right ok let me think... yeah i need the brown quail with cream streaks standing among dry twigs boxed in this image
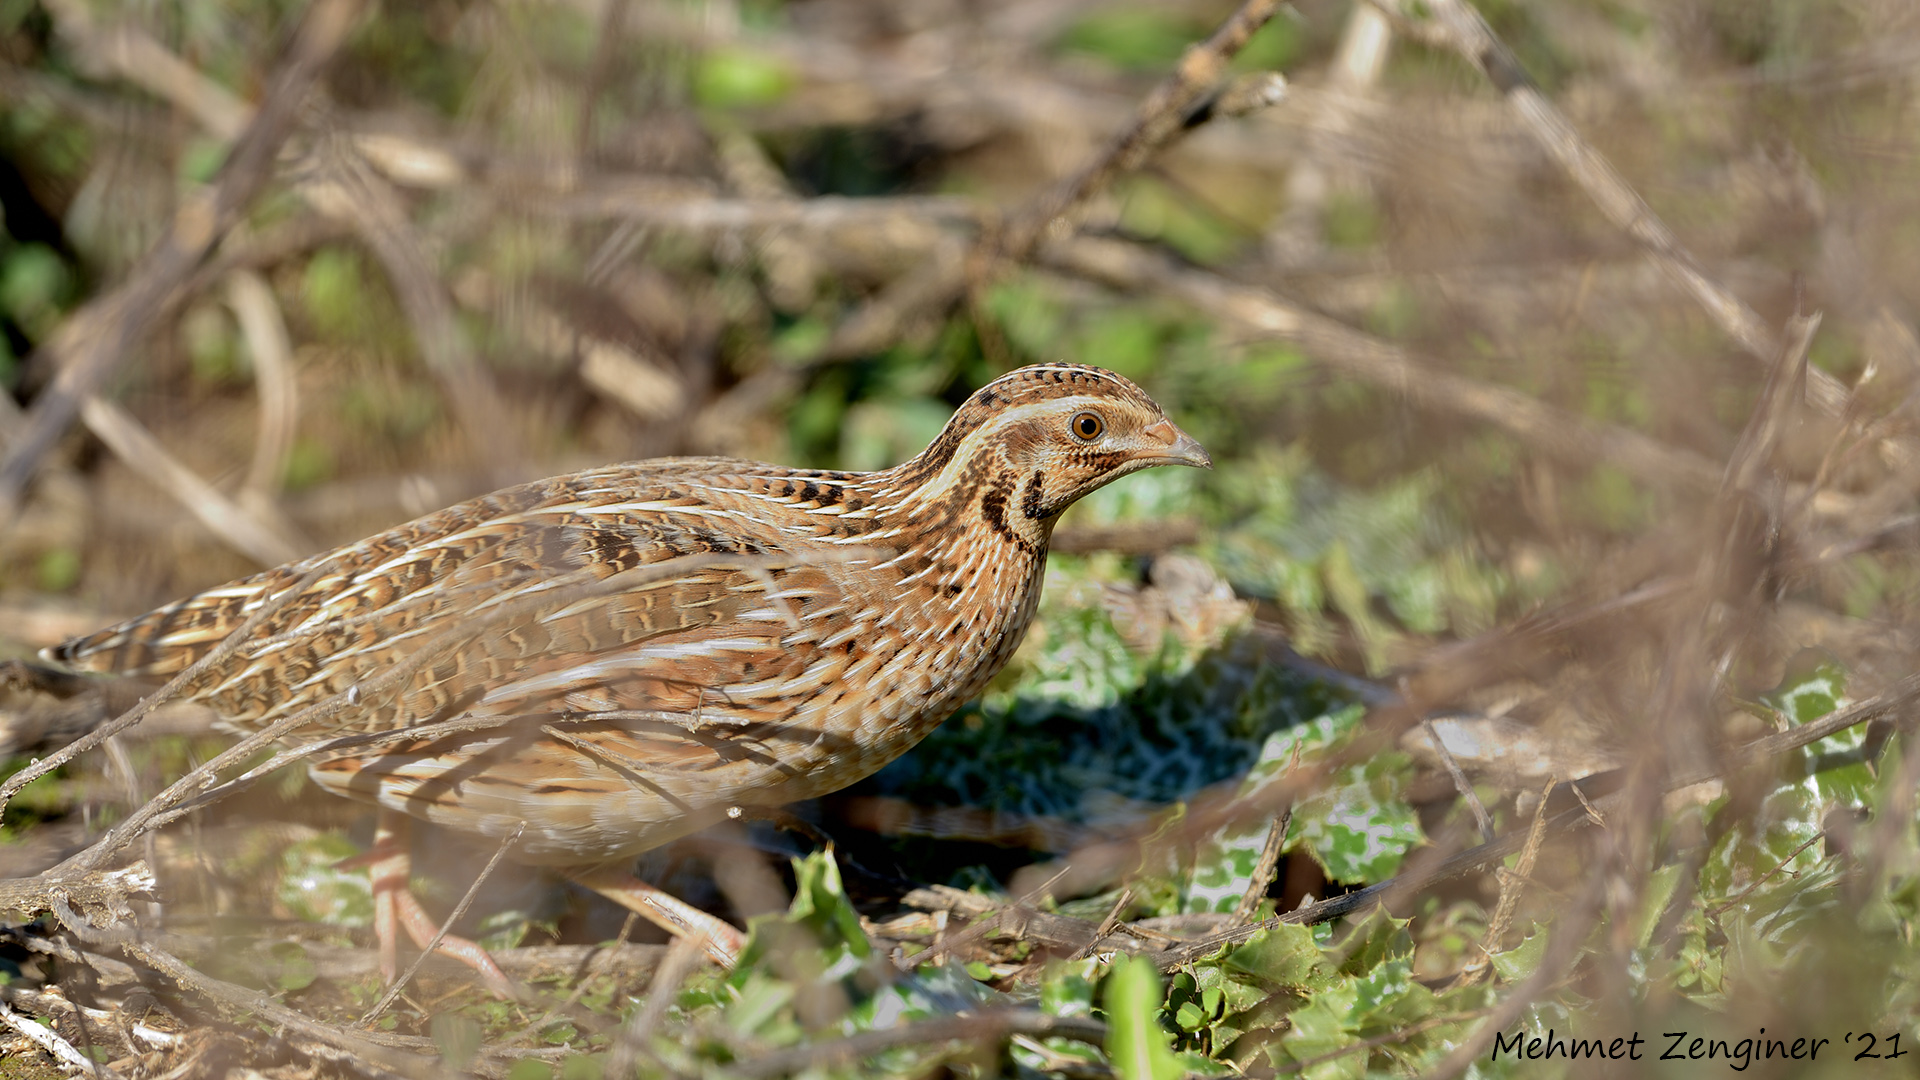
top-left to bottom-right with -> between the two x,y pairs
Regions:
46,365 -> 1210,983
